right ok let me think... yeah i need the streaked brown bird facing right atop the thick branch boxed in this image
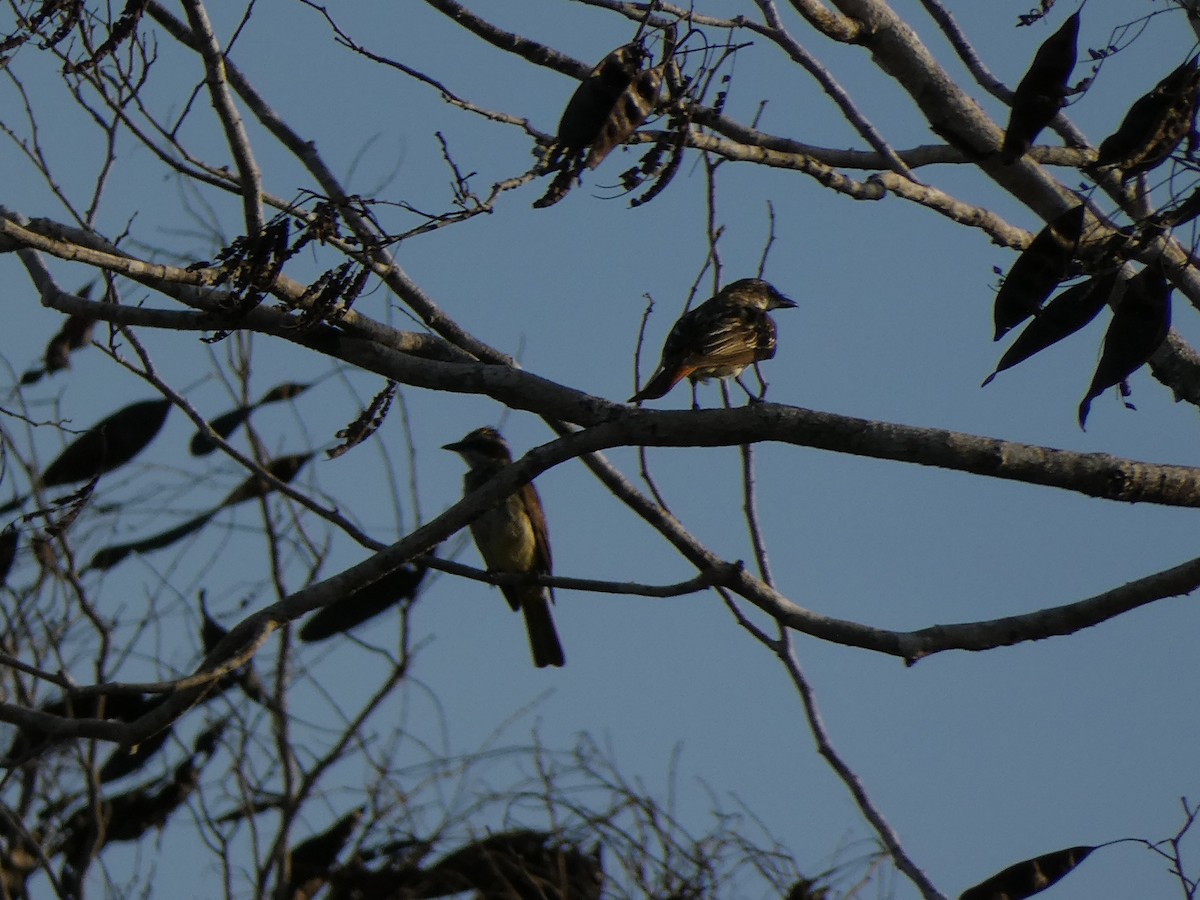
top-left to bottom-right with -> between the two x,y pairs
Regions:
629,278 -> 796,408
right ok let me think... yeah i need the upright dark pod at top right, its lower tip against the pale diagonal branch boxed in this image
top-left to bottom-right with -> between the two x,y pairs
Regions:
1000,11 -> 1079,164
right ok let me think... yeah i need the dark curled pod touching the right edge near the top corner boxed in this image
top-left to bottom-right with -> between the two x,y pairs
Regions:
1096,56 -> 1200,179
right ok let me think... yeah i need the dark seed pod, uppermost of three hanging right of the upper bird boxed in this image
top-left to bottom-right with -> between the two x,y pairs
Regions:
992,203 -> 1086,341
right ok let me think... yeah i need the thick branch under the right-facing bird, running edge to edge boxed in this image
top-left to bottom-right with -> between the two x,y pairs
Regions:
0,207 -> 1200,506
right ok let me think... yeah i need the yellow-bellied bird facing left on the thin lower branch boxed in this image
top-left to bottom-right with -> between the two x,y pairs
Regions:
443,426 -> 565,668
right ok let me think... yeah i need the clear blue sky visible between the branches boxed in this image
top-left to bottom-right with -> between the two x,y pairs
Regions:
0,0 -> 1200,900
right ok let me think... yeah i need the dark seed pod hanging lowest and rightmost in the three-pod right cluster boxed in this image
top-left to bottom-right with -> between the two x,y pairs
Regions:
1079,264 -> 1171,430
